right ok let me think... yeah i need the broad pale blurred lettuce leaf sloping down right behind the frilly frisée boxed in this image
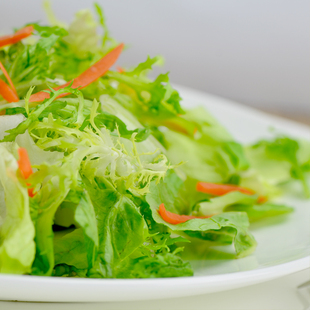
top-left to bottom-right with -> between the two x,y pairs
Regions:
163,108 -> 249,183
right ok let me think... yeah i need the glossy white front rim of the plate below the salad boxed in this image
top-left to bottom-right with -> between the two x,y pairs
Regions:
0,256 -> 310,302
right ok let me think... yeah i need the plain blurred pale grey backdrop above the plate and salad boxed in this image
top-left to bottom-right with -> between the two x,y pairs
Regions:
0,0 -> 310,125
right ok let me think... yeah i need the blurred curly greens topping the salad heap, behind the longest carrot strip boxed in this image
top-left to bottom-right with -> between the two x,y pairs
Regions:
0,5 -> 117,100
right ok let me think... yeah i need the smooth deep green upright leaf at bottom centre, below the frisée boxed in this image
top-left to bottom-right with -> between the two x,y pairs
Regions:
83,178 -> 148,278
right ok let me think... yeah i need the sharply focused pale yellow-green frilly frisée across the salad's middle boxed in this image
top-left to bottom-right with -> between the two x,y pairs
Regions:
3,87 -> 170,199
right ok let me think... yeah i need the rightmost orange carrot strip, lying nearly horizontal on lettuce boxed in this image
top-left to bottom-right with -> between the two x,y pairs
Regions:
196,182 -> 267,203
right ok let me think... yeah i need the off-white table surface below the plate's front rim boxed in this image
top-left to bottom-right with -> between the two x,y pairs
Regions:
0,269 -> 310,310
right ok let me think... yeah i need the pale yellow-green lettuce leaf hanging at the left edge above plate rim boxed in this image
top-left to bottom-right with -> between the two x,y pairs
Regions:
0,144 -> 35,274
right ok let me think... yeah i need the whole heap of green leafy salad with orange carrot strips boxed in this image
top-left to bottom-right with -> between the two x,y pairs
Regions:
0,5 -> 310,278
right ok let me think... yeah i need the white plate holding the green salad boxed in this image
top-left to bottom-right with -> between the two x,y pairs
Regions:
0,87 -> 310,302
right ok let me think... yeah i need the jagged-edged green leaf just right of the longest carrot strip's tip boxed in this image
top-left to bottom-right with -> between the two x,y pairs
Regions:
106,58 -> 184,120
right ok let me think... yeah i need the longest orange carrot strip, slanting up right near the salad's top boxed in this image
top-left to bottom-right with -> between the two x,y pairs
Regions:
29,43 -> 124,102
